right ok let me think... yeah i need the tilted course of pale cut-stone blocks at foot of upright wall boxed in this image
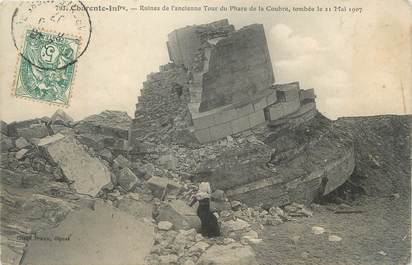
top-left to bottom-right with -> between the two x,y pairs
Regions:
191,82 -> 316,143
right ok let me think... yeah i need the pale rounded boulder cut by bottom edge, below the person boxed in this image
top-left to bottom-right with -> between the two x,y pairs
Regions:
197,243 -> 258,265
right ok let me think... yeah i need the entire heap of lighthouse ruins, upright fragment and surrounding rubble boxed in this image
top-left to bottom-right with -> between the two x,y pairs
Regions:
0,20 -> 410,265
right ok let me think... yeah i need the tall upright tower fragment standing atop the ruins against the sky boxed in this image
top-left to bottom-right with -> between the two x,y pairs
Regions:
130,20 -> 316,144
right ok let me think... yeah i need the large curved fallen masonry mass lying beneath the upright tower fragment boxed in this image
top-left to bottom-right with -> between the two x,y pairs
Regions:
195,114 -> 355,205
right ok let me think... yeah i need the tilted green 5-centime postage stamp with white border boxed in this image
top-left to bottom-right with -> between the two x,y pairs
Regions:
14,29 -> 80,105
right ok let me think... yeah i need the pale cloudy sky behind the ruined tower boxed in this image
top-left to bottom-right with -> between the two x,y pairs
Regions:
0,0 -> 412,122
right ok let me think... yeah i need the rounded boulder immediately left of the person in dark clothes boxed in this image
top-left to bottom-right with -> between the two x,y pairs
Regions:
156,200 -> 200,230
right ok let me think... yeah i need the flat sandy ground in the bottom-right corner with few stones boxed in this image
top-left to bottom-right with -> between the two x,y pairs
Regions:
255,193 -> 411,265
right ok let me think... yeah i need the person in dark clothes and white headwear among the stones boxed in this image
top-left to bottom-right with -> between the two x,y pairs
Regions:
190,182 -> 220,237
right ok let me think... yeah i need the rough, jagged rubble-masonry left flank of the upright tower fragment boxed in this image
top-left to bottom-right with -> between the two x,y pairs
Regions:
129,64 -> 194,144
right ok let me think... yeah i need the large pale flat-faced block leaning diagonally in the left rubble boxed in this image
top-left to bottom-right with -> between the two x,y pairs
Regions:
40,135 -> 110,196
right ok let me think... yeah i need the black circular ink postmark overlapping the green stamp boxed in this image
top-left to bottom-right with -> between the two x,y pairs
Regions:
11,1 -> 92,70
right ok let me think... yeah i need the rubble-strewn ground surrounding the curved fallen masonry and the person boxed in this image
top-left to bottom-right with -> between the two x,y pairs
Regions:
1,111 -> 411,265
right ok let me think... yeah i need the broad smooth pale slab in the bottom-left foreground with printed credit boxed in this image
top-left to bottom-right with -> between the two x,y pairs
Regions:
21,200 -> 154,265
